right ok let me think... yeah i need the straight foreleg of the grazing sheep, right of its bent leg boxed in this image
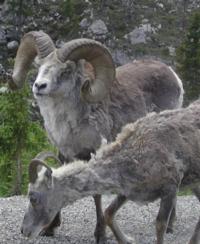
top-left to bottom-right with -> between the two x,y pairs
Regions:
156,186 -> 177,244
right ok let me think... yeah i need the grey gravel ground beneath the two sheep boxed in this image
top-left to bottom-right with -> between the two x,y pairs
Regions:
0,196 -> 200,244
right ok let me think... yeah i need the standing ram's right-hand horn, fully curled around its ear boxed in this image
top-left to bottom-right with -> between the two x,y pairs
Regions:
57,38 -> 115,102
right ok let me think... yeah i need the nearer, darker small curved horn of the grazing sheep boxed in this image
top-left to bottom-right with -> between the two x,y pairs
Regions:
28,158 -> 52,184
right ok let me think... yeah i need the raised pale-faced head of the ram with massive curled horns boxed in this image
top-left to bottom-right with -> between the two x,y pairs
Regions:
9,31 -> 115,102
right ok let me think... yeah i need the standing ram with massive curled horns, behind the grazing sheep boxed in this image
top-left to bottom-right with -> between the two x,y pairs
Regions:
9,31 -> 183,242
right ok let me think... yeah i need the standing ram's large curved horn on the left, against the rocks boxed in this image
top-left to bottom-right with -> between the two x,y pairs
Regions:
9,31 -> 55,89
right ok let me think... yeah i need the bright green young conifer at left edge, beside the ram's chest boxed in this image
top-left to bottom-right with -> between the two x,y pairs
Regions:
0,84 -> 52,196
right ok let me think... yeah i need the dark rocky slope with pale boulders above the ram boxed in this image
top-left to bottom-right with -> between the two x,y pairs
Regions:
0,0 -> 200,65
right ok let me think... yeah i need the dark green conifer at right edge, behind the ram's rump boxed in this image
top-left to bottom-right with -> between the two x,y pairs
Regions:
177,11 -> 200,102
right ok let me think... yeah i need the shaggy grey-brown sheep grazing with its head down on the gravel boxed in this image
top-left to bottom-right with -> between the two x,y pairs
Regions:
22,100 -> 200,244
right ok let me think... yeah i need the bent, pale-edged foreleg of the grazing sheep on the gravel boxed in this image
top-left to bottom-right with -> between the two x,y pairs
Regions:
104,195 -> 134,244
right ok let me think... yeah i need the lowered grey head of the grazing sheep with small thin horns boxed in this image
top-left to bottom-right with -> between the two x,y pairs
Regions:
21,153 -> 62,238
